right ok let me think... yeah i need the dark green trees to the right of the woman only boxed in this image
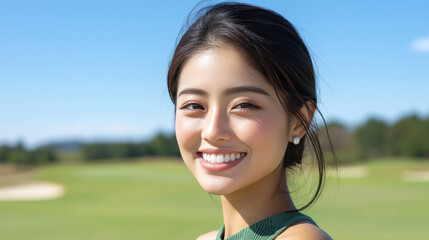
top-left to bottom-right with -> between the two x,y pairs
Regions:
321,115 -> 429,162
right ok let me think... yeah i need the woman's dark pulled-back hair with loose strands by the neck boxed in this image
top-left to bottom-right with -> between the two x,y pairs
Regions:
167,2 -> 332,210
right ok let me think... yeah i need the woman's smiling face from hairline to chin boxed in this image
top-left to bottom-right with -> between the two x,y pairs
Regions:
175,47 -> 292,195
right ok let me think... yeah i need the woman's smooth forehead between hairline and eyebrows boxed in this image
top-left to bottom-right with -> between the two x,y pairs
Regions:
178,47 -> 274,91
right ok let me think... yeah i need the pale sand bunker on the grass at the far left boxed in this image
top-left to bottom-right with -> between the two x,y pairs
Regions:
0,182 -> 64,201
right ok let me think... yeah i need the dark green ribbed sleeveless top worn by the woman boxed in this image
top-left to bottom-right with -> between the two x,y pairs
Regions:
216,211 -> 317,240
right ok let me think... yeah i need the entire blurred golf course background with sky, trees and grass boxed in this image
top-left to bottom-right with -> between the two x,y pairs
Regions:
0,0 -> 429,240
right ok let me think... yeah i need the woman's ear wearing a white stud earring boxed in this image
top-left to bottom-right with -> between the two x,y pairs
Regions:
289,101 -> 316,142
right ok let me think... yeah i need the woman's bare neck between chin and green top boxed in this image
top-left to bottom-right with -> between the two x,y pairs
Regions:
221,167 -> 296,238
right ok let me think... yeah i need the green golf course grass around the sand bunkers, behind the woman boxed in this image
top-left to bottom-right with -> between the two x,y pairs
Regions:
0,159 -> 429,240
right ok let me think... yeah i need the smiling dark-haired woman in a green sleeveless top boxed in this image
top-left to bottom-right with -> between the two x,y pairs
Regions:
167,3 -> 330,240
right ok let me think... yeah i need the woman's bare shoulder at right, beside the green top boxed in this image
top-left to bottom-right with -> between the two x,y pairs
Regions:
276,223 -> 332,240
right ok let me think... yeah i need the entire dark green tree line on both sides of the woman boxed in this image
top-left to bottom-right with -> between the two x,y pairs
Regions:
0,115 -> 429,165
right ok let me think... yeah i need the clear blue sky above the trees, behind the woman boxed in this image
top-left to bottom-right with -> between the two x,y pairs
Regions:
0,0 -> 429,146
